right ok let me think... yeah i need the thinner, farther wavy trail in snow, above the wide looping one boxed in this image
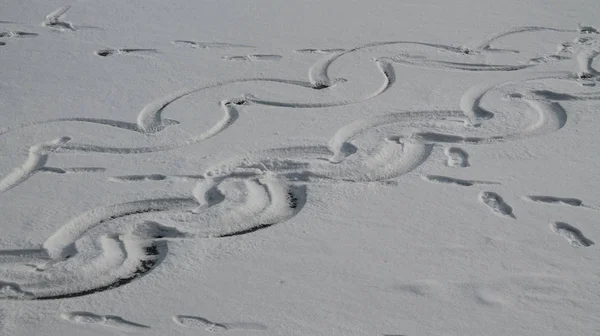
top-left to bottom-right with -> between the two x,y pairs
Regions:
0,25 -> 571,154
